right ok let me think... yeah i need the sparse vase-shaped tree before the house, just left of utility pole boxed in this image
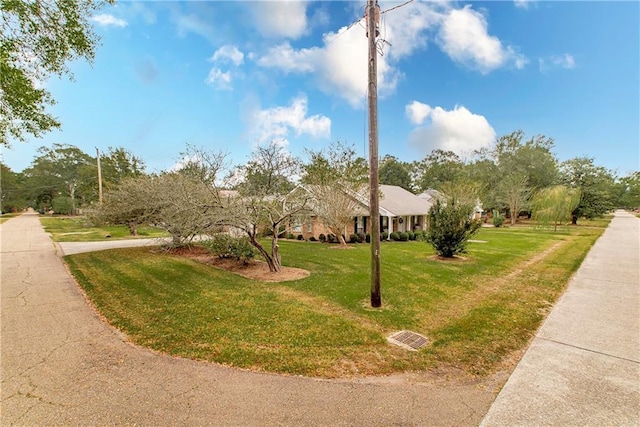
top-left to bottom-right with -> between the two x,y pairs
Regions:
302,143 -> 368,246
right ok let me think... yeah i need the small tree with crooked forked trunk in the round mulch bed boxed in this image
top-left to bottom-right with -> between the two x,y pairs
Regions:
221,142 -> 311,272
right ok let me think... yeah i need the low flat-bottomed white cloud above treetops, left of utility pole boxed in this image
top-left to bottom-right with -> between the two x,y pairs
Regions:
252,95 -> 331,144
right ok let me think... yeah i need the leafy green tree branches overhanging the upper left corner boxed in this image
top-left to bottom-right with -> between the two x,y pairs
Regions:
0,0 -> 112,146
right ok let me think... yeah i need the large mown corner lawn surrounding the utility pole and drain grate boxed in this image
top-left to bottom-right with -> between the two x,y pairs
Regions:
65,227 -> 604,377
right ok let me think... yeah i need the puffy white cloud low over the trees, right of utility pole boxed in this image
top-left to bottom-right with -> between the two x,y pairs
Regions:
405,101 -> 496,154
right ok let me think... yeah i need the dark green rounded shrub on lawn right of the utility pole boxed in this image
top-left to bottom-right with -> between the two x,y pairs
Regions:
424,199 -> 481,258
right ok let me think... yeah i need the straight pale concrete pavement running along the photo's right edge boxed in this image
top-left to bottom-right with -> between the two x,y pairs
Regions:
481,211 -> 640,426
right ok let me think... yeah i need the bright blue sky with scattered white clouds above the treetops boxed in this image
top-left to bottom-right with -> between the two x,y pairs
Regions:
2,0 -> 640,175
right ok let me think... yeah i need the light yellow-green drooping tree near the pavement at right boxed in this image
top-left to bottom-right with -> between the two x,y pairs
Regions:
531,185 -> 580,231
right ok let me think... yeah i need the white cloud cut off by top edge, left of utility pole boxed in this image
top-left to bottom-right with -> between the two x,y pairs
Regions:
252,0 -> 307,39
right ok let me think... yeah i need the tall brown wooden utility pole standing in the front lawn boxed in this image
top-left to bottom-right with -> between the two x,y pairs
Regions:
366,0 -> 382,307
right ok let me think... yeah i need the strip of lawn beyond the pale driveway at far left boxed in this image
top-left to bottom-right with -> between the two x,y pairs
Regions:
40,216 -> 168,242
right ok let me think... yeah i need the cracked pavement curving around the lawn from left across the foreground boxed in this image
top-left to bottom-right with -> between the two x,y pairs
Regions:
0,214 -> 505,426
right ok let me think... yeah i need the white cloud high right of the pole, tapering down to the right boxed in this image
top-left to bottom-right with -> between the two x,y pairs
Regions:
437,5 -> 528,74
